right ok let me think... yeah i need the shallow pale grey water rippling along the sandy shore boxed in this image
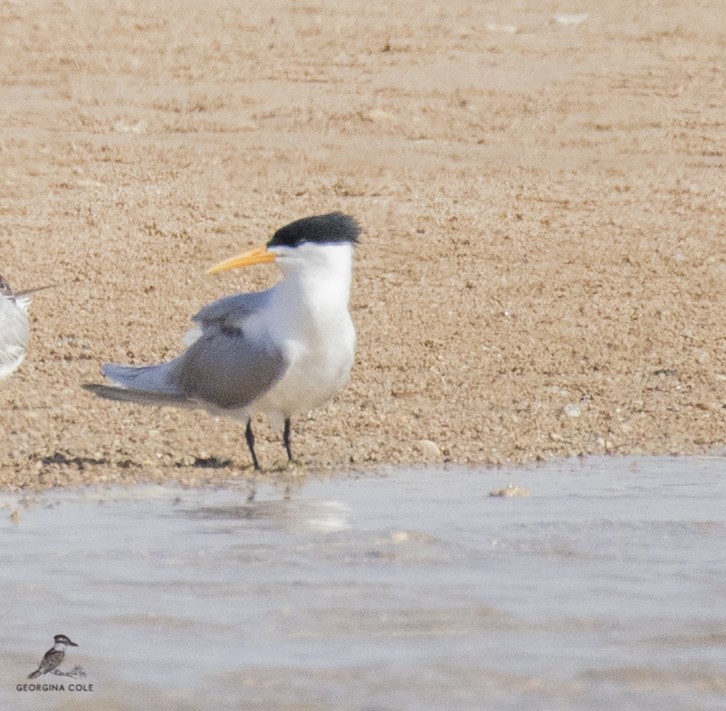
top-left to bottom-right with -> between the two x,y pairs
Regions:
0,457 -> 726,711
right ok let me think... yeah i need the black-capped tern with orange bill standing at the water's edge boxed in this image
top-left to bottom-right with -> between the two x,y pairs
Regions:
85,212 -> 360,470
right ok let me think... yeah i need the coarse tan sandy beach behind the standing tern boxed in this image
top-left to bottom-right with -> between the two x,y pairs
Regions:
0,0 -> 726,490
